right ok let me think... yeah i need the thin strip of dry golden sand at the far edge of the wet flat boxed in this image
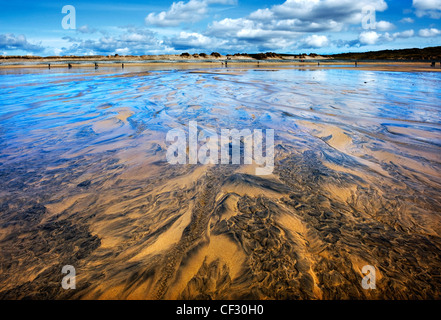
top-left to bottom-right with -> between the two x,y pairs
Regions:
0,56 -> 441,73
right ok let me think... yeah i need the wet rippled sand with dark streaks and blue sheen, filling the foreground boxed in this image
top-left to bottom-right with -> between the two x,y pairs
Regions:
0,67 -> 441,299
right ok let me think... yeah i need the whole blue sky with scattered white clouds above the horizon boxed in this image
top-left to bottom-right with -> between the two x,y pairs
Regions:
0,0 -> 441,56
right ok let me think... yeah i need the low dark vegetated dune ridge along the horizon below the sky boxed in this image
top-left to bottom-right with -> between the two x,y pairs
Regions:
0,46 -> 441,61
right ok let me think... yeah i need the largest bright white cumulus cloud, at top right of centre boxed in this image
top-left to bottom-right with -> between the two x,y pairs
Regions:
207,0 -> 386,50
